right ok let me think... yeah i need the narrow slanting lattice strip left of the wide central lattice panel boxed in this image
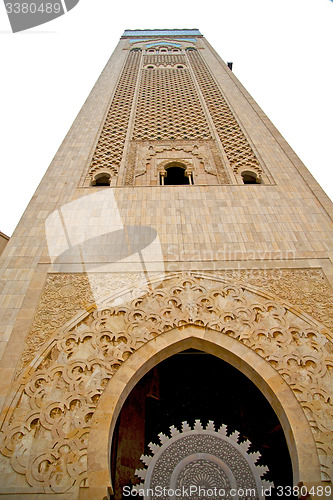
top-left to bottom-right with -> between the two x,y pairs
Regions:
90,51 -> 141,172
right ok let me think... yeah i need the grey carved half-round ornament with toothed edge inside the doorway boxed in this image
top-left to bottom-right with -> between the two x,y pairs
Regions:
134,420 -> 274,500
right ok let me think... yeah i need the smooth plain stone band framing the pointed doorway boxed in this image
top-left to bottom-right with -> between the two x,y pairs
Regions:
87,325 -> 320,498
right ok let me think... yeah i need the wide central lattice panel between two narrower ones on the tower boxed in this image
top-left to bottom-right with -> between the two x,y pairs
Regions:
133,66 -> 211,140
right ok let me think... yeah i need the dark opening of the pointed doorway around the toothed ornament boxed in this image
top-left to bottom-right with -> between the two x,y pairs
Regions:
111,349 -> 293,500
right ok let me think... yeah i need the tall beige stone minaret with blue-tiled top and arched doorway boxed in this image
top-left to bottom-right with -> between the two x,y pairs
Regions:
0,29 -> 333,500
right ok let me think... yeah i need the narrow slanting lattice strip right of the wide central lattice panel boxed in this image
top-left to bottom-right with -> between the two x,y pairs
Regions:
187,50 -> 262,174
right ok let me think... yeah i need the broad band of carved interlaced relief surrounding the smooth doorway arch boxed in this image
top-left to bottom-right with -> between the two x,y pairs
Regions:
1,270 -> 333,492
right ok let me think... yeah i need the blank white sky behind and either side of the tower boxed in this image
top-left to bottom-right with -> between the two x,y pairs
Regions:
0,0 -> 333,236
